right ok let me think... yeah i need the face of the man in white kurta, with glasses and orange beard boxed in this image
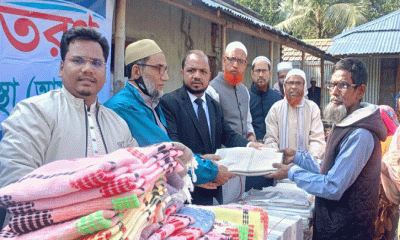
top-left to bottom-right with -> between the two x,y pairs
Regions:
284,75 -> 305,106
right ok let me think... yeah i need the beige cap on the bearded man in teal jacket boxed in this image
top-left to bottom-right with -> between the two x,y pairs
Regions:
125,39 -> 162,65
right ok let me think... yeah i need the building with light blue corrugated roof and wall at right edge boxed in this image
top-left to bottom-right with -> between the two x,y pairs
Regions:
328,10 -> 400,107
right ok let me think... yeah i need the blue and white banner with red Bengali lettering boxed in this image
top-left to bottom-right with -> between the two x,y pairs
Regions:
0,0 -> 115,126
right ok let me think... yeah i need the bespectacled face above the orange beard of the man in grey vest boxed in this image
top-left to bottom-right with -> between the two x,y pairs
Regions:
223,48 -> 247,75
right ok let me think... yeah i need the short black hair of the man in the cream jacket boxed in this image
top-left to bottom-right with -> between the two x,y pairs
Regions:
60,27 -> 110,61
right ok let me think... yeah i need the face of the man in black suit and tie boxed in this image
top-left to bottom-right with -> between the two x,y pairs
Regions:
181,54 -> 211,97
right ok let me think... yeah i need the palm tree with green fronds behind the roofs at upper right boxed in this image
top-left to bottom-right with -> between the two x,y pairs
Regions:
275,0 -> 369,38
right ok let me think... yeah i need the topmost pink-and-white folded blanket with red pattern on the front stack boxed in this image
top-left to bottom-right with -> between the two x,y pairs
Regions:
0,143 -> 182,207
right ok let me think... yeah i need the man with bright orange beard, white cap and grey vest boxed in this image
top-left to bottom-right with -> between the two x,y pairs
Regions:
207,41 -> 256,142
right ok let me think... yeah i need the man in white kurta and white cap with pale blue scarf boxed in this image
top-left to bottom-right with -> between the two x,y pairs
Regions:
264,69 -> 326,159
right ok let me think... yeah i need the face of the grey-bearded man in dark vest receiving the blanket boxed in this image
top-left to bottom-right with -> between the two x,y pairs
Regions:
329,70 -> 365,114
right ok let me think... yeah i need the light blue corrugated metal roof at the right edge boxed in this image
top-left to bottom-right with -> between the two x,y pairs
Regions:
327,10 -> 400,55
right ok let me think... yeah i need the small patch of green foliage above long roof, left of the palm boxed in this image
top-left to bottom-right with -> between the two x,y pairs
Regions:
236,0 -> 283,26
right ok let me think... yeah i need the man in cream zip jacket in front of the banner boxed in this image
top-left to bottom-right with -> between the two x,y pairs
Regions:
0,27 -> 138,187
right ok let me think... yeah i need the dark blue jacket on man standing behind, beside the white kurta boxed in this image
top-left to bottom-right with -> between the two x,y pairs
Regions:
249,82 -> 281,140
